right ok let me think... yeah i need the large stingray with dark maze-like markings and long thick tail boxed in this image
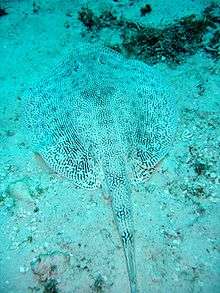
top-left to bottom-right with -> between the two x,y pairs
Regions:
25,44 -> 177,293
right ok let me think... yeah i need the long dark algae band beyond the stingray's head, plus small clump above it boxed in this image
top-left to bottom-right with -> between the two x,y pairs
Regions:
78,4 -> 220,64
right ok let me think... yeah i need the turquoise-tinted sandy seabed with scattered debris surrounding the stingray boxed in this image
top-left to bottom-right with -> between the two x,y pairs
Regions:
0,0 -> 220,293
